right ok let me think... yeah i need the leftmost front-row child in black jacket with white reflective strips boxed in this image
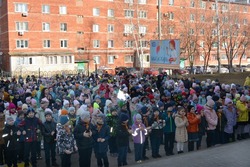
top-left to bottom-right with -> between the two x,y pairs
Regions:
3,117 -> 21,167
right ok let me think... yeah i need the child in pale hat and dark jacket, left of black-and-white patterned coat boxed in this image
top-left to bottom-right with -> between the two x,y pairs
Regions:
42,108 -> 58,167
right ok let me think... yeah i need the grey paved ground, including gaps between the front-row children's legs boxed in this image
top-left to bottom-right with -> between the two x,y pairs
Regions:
29,137 -> 250,167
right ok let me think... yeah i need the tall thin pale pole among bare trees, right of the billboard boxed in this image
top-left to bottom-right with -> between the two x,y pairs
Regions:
215,0 -> 221,73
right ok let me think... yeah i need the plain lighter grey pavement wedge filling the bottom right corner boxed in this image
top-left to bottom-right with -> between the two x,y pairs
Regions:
132,140 -> 250,167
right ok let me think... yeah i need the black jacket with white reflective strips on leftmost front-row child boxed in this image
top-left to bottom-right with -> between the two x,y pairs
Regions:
3,124 -> 20,151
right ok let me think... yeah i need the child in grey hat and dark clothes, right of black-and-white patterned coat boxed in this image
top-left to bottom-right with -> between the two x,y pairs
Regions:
74,111 -> 95,167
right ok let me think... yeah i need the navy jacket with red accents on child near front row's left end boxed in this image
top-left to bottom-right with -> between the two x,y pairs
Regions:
19,117 -> 43,142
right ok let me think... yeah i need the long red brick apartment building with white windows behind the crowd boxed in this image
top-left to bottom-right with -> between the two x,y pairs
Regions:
0,0 -> 250,75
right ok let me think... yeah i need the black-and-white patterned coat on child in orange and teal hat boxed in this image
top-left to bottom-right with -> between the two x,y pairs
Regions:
57,124 -> 76,154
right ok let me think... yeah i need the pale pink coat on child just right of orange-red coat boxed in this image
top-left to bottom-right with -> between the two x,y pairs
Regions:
204,106 -> 218,130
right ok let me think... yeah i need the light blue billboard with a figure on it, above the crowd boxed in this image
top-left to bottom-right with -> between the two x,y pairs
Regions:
150,39 -> 180,69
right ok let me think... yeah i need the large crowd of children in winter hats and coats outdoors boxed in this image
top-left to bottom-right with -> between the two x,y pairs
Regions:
0,73 -> 250,167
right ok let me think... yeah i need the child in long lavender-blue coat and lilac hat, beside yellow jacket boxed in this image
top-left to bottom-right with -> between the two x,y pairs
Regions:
223,98 -> 237,143
